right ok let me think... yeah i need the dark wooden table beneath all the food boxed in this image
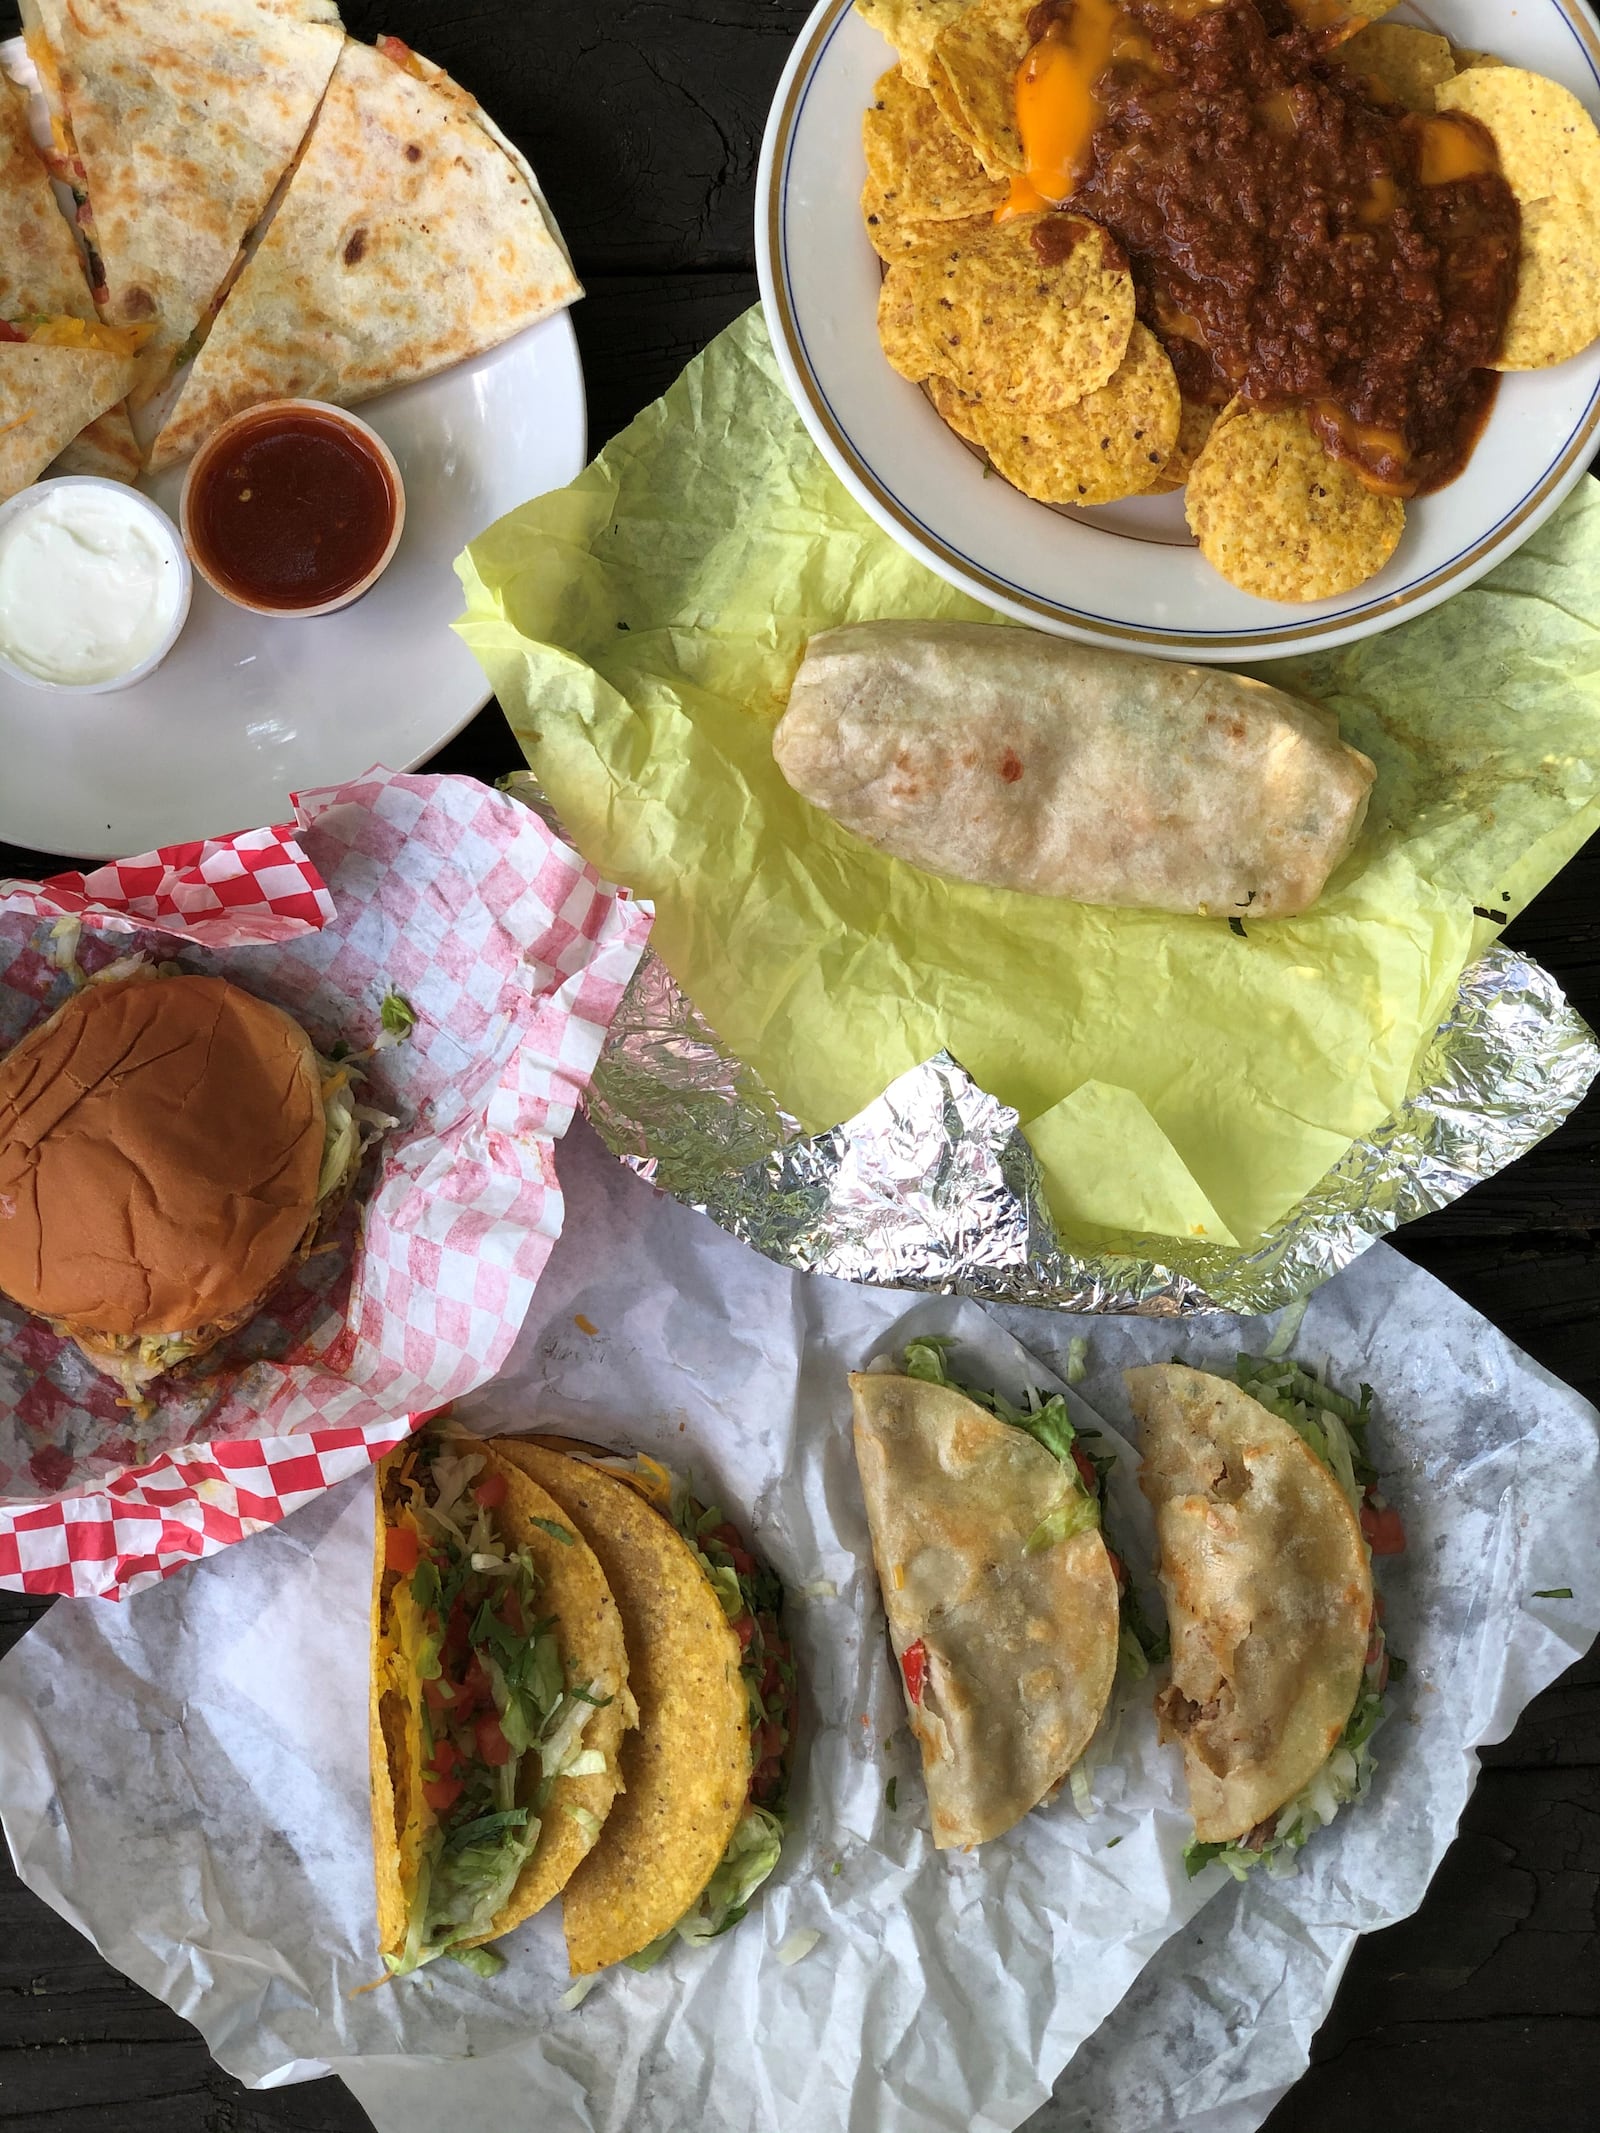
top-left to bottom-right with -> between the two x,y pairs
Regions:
0,0 -> 1600,2133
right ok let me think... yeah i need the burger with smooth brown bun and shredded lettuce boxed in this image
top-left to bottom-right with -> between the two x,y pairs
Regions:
0,962 -> 371,1399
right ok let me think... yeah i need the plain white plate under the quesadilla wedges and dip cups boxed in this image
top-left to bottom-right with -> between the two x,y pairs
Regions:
0,45 -> 587,857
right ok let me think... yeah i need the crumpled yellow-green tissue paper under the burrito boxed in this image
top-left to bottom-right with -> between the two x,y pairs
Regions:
457,311 -> 1600,1250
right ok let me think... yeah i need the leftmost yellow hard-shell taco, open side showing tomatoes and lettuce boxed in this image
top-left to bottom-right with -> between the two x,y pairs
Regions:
371,1429 -> 636,1977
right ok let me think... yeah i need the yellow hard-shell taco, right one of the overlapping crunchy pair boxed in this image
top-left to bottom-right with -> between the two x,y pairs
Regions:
495,1438 -> 794,1977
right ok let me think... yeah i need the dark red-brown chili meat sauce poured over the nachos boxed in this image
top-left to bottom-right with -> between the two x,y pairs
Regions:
1058,0 -> 1521,495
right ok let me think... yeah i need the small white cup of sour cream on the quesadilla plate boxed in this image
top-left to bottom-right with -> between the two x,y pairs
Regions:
0,474 -> 194,695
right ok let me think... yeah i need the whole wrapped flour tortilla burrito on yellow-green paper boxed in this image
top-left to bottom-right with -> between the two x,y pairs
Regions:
772,623 -> 1376,919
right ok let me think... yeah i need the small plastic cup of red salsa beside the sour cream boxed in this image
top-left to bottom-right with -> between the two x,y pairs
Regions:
179,399 -> 405,619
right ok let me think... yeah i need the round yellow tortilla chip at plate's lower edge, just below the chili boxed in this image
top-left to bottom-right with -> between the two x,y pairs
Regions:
1184,401 -> 1406,599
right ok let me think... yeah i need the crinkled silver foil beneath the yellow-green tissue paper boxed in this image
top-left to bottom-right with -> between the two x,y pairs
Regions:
506,772 -> 1600,1316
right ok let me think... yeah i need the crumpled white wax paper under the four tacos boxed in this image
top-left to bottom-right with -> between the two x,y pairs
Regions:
0,1135 -> 1600,2133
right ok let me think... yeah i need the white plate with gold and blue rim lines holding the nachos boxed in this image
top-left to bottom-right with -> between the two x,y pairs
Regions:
755,0 -> 1600,659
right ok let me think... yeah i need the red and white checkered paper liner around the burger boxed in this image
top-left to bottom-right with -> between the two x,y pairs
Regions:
0,770 -> 651,1598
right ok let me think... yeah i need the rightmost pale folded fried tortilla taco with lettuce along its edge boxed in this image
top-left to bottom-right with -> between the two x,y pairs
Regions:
1126,1357 -> 1404,1875
